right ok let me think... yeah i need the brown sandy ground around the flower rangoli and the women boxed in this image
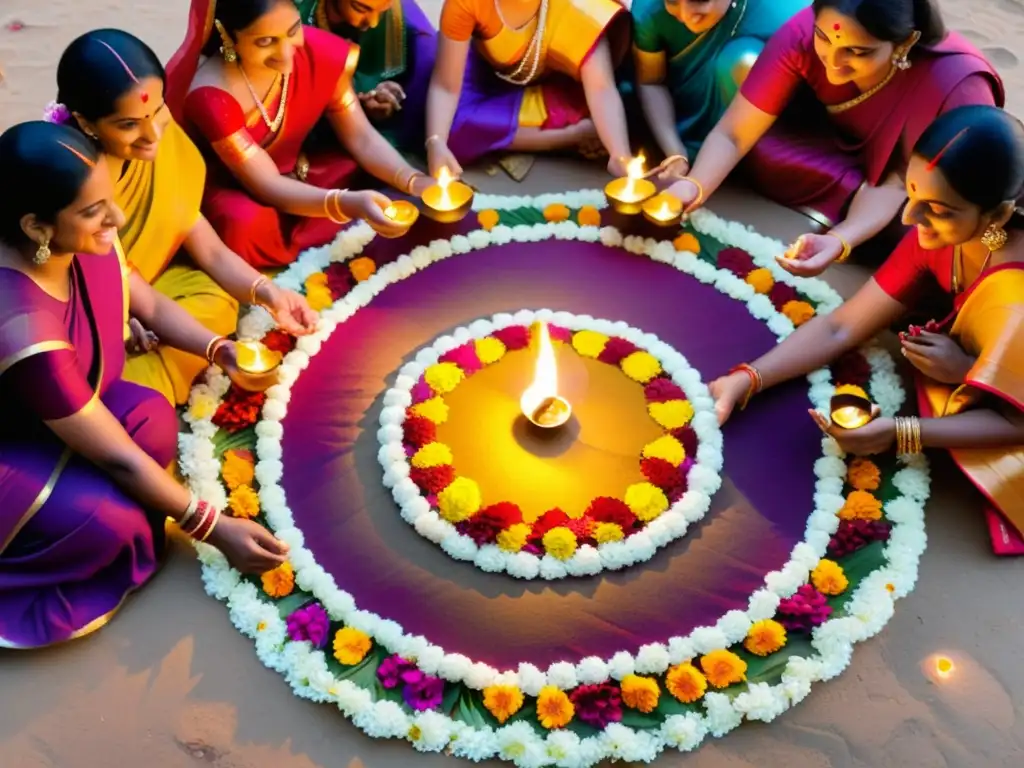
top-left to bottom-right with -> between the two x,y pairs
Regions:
0,0 -> 1024,768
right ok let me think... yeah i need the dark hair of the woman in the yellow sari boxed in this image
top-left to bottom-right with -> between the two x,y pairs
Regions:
57,30 -> 167,121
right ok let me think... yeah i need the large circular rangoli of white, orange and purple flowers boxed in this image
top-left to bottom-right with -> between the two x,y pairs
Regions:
180,193 -> 929,766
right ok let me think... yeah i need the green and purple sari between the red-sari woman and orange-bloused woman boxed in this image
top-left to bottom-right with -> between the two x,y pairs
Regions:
295,0 -> 437,152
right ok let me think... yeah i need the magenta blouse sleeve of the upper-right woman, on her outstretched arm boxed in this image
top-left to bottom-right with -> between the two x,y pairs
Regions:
739,9 -> 814,117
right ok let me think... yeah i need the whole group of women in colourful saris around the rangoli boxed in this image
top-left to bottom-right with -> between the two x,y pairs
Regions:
0,0 -> 1024,648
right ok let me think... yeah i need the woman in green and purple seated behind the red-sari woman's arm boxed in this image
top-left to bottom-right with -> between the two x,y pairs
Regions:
295,0 -> 437,152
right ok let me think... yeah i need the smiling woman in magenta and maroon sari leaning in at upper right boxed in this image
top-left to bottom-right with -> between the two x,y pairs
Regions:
673,0 -> 1004,274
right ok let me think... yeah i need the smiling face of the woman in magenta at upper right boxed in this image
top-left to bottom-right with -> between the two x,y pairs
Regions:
814,8 -> 895,85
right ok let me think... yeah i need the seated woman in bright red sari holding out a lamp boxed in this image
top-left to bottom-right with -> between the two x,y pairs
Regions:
167,0 -> 433,269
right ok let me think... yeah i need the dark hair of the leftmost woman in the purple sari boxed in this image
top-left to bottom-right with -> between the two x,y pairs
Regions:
0,121 -> 99,246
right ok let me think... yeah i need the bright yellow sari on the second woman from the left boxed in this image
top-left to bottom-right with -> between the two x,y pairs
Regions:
114,121 -> 239,406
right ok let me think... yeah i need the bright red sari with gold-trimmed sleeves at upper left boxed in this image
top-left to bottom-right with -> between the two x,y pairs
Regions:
167,0 -> 359,269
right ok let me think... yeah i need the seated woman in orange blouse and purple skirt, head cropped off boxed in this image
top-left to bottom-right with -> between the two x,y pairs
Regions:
426,0 -> 630,176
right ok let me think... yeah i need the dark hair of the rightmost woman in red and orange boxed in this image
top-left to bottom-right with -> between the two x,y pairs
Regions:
913,105 -> 1024,225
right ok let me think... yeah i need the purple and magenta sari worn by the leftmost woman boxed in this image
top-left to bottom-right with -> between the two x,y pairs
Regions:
0,247 -> 177,648
